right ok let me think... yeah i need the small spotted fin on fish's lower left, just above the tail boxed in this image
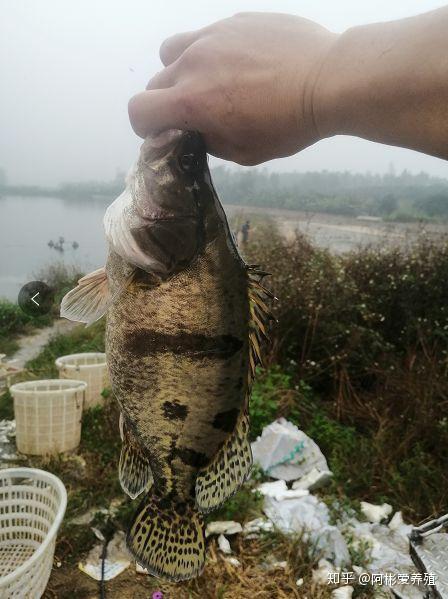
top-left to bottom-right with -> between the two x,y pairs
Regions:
118,414 -> 154,499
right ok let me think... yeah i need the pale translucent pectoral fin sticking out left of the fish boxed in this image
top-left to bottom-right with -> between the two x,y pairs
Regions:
61,267 -> 111,324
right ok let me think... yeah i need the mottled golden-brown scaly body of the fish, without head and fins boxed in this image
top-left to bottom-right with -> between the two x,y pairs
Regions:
107,232 -> 249,496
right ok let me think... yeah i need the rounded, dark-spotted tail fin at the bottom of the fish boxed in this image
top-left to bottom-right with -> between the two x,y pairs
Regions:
127,495 -> 205,582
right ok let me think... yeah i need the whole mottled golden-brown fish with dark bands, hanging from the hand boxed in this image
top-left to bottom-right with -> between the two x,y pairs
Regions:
61,130 -> 270,581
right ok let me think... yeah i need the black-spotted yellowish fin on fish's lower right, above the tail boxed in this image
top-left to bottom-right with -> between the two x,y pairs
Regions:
196,412 -> 252,512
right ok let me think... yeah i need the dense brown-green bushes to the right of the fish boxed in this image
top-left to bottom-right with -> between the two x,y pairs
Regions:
246,223 -> 448,518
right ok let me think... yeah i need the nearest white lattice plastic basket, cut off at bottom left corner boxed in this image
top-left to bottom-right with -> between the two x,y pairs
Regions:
0,468 -> 67,599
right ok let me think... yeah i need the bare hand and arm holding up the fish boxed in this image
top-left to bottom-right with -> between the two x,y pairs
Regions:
129,7 -> 448,165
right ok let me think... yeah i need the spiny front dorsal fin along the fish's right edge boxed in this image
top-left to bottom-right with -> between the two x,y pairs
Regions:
248,266 -> 275,389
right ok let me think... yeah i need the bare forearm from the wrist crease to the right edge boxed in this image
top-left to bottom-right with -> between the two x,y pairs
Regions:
314,7 -> 448,158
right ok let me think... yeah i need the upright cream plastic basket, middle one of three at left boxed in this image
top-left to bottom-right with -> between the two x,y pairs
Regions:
10,379 -> 87,455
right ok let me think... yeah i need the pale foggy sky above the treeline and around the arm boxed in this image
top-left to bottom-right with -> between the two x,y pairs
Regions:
0,0 -> 448,185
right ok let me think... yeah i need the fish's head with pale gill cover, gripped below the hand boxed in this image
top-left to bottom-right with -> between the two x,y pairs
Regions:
104,130 -> 208,279
